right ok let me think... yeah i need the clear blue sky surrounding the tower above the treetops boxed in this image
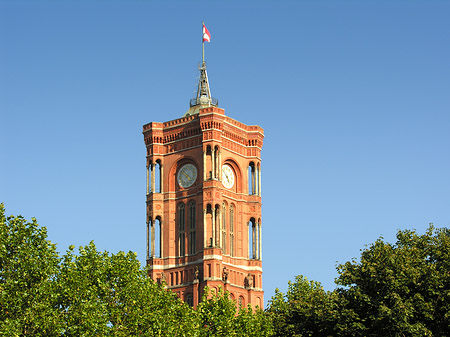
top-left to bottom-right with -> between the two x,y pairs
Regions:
0,0 -> 450,300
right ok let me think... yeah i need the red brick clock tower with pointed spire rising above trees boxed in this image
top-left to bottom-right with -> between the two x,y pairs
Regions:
143,57 -> 264,308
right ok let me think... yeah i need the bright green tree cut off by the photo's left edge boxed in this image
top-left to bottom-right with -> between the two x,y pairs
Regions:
0,204 -> 60,336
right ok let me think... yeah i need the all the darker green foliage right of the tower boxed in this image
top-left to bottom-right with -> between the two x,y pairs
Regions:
268,226 -> 450,336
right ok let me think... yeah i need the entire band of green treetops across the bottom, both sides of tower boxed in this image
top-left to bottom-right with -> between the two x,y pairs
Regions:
0,204 -> 450,337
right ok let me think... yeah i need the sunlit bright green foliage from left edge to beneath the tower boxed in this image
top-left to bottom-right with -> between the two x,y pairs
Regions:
0,204 -> 272,337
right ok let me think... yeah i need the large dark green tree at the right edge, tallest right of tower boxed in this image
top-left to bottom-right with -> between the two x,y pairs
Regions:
336,225 -> 450,336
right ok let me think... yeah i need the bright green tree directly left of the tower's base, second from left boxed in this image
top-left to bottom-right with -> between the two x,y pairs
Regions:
58,242 -> 195,336
